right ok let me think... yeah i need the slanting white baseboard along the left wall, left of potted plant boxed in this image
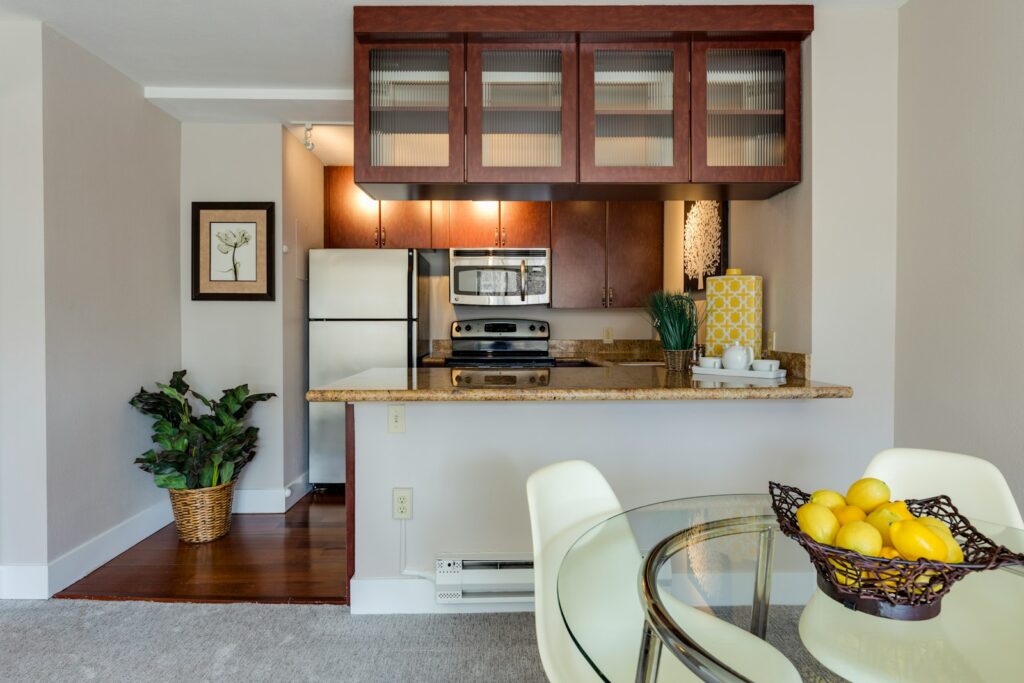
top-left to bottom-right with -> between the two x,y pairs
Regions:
46,499 -> 174,597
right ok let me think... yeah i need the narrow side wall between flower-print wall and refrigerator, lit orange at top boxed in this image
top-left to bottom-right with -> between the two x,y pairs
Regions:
281,129 -> 324,489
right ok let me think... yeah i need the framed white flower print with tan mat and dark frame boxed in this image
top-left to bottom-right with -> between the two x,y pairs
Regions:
193,202 -> 274,301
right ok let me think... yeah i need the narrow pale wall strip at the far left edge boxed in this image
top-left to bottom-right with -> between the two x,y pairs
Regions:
0,22 -> 47,585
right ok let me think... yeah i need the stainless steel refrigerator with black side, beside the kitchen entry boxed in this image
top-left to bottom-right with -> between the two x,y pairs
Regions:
308,249 -> 430,484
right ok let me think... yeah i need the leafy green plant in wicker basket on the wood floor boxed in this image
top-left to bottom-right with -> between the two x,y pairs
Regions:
129,370 -> 274,543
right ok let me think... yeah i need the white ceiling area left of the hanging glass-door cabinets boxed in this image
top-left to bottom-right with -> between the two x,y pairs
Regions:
0,0 -> 905,162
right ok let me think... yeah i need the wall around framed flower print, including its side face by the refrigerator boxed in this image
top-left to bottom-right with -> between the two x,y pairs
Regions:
180,123 -> 324,512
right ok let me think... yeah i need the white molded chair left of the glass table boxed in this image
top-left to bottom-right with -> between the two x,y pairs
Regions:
526,460 -> 801,683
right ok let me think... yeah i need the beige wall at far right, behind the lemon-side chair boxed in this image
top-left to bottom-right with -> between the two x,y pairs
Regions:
896,0 -> 1024,501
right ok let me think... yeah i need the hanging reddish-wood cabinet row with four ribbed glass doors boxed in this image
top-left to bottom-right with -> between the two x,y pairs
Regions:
354,5 -> 814,202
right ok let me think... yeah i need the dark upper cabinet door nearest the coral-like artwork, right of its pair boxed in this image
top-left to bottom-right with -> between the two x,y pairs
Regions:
606,202 -> 663,308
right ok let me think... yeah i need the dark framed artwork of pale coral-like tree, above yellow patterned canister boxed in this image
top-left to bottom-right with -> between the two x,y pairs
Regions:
683,200 -> 729,292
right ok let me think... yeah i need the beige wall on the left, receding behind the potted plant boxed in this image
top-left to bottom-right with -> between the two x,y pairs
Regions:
43,28 -> 181,560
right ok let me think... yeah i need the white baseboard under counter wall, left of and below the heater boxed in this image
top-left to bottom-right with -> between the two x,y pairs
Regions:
348,577 -> 534,614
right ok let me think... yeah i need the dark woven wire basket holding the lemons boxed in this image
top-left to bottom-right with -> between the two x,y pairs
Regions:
768,481 -> 1024,622
